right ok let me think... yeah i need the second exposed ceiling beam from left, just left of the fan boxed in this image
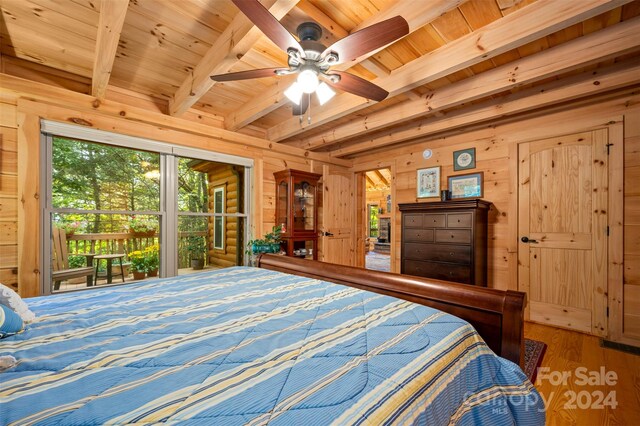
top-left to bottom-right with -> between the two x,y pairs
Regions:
169,0 -> 299,115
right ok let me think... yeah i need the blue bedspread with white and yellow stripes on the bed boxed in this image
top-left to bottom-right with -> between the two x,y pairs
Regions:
0,267 -> 544,425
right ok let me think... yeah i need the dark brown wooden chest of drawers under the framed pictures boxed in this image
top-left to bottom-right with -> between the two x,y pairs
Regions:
399,199 -> 491,286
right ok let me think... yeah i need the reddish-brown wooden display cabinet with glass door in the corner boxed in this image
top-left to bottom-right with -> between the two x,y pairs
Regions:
273,169 -> 322,260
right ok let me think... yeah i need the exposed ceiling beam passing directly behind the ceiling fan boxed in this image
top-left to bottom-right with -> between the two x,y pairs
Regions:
225,0 -> 463,130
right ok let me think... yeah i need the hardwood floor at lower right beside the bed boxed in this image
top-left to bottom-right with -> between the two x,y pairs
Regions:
524,323 -> 640,425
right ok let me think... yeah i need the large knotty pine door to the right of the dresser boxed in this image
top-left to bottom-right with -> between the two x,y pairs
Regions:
518,129 -> 608,336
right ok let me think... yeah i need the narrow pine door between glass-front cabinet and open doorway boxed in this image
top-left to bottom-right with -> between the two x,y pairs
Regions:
319,166 -> 355,266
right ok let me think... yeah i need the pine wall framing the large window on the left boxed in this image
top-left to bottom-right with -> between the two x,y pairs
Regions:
0,74 -> 352,297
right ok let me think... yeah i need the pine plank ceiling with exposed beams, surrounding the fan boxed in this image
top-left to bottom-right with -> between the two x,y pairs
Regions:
0,0 -> 640,157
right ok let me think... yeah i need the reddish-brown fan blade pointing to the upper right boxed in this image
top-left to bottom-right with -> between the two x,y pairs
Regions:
321,16 -> 409,65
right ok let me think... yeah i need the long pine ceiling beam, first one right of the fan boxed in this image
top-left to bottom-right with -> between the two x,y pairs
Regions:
267,0 -> 629,141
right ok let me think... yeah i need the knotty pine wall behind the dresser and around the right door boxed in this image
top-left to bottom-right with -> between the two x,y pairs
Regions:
354,90 -> 640,345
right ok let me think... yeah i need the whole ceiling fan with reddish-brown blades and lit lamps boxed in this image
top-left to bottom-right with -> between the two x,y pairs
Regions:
211,0 -> 409,115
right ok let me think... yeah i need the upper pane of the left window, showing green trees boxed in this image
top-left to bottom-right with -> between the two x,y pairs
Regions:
52,136 -> 160,211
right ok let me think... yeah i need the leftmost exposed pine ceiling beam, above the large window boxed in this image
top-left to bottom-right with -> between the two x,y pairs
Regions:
91,0 -> 129,99
